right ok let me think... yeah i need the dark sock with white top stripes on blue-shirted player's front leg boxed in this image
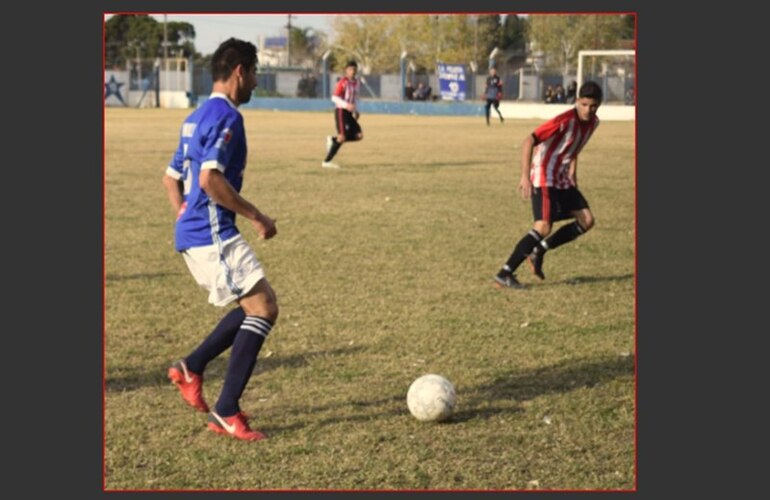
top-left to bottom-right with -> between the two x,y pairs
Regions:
216,316 -> 273,417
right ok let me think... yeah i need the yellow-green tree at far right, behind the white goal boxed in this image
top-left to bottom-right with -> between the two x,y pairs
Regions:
529,14 -> 624,75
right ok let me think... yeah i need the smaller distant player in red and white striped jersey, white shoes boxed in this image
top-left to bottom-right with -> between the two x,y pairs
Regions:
321,61 -> 364,168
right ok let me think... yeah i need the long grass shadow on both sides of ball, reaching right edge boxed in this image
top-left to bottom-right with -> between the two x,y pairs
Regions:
280,356 -> 634,426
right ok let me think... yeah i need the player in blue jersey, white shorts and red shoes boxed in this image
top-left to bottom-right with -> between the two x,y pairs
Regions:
163,38 -> 278,441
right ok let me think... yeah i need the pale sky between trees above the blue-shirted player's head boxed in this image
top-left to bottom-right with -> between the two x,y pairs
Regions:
147,14 -> 335,55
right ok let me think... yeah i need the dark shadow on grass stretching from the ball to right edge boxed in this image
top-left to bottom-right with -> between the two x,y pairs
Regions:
451,356 -> 634,422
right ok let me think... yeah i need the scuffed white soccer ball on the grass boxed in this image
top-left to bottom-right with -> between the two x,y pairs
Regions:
406,373 -> 457,422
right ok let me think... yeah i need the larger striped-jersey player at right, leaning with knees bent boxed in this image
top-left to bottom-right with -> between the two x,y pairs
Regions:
495,81 -> 602,288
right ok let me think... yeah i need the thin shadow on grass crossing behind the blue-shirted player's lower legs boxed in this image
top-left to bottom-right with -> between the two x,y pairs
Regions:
106,346 -> 363,392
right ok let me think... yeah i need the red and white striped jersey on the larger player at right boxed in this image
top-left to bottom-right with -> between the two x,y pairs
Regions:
530,108 -> 599,189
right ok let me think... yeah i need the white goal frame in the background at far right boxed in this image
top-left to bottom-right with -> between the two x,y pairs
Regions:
577,50 -> 636,104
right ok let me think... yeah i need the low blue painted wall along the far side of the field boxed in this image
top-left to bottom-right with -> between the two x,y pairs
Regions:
198,95 -> 484,116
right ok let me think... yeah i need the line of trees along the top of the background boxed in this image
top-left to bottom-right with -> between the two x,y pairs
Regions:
105,14 -> 635,74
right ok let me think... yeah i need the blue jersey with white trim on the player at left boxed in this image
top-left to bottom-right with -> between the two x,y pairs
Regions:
166,93 -> 246,252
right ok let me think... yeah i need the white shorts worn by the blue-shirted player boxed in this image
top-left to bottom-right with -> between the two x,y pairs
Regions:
182,234 -> 265,307
